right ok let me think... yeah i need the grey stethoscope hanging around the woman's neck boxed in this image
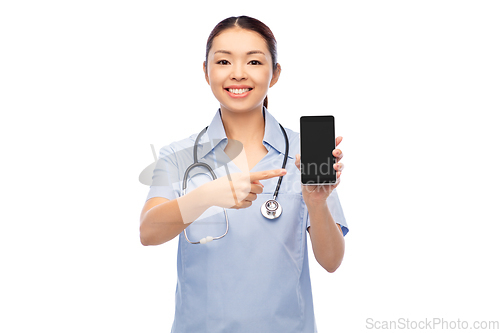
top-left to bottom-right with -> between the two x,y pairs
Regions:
182,120 -> 289,244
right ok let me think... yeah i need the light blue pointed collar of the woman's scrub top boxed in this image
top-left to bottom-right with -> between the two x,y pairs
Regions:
198,106 -> 294,159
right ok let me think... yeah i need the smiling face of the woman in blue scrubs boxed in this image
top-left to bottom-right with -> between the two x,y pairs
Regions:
203,28 -> 281,112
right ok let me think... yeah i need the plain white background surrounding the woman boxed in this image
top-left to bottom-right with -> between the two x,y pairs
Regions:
0,0 -> 500,333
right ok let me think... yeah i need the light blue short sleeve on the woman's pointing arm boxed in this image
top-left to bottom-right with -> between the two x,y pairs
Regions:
146,145 -> 179,201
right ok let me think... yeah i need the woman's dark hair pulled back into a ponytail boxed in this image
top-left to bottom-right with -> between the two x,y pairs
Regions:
205,16 -> 278,108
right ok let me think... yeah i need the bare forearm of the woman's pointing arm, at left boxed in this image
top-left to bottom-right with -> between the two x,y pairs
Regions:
140,186 -> 211,245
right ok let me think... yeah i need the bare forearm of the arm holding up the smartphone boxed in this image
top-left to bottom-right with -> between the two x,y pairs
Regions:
307,202 -> 345,273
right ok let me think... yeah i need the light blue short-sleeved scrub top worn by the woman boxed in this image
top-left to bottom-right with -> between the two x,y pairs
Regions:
147,107 -> 349,333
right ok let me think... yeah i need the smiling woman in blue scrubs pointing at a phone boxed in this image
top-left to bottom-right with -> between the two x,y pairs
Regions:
140,16 -> 348,332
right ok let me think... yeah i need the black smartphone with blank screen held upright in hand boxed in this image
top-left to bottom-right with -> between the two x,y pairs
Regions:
300,115 -> 337,185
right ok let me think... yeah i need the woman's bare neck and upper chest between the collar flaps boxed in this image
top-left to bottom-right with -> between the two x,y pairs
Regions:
221,105 -> 265,145
